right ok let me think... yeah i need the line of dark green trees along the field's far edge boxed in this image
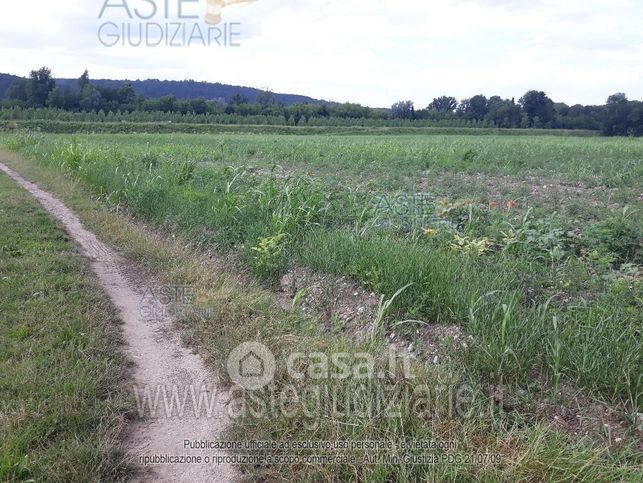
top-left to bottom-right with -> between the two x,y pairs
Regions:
2,67 -> 643,136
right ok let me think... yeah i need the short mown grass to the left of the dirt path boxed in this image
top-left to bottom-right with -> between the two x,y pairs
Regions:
0,170 -> 129,482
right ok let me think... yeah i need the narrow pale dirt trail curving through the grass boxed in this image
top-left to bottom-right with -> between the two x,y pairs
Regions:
0,163 -> 236,482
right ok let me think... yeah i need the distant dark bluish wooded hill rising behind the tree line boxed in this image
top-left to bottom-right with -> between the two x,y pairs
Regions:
0,73 -> 325,106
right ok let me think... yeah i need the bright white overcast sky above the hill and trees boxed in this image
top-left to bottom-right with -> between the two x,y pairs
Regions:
0,0 -> 643,107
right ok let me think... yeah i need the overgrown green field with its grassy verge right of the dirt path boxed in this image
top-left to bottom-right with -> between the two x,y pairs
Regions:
0,131 -> 643,481
